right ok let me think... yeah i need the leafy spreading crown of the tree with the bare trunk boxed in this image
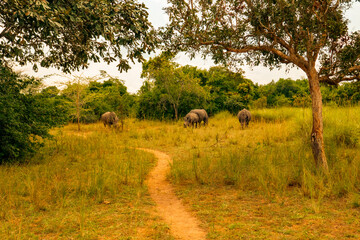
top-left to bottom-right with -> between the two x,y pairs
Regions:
162,0 -> 359,81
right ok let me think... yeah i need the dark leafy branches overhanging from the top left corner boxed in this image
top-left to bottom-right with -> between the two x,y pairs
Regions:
0,0 -> 156,72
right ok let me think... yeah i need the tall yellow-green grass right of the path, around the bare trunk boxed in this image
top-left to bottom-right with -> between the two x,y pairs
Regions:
172,108 -> 360,201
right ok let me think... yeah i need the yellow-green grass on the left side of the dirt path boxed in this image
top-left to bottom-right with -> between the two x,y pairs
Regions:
0,125 -> 161,239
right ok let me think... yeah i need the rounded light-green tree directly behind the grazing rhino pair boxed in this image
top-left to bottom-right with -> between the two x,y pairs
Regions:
138,53 -> 206,120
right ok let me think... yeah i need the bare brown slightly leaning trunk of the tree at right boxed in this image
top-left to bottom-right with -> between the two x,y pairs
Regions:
307,68 -> 328,171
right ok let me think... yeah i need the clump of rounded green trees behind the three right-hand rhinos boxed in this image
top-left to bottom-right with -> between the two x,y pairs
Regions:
138,53 -> 254,119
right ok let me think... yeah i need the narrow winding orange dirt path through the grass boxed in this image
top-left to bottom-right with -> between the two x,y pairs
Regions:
138,148 -> 206,240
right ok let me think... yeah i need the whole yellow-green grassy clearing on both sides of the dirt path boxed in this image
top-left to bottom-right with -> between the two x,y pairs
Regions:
0,107 -> 360,239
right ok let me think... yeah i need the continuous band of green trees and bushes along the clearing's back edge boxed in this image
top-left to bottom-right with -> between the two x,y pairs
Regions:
0,62 -> 360,161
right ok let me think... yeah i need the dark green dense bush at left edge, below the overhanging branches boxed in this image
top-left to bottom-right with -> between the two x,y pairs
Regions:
0,65 -> 67,164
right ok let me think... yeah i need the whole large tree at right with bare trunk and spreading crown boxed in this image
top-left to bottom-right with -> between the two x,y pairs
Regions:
164,0 -> 360,170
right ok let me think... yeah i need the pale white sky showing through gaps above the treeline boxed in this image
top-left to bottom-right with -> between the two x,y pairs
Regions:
15,0 -> 360,93
